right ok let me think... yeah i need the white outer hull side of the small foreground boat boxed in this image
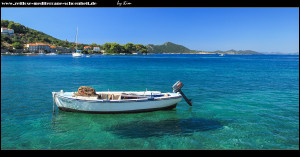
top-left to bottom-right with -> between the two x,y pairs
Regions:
52,92 -> 182,113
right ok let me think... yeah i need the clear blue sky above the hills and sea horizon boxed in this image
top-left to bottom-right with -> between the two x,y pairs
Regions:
1,8 -> 299,53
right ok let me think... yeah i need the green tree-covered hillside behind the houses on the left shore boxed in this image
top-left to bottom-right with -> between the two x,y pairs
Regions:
1,20 -> 147,54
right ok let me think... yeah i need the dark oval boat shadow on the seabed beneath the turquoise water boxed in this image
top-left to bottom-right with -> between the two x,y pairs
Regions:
107,118 -> 223,138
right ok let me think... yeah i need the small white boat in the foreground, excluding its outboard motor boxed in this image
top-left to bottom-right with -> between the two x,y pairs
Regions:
52,81 -> 192,113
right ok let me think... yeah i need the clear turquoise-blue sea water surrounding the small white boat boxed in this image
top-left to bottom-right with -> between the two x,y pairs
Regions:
1,55 -> 299,149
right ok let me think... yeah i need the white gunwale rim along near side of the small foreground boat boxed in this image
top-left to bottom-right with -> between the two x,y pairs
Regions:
54,92 -> 182,103
